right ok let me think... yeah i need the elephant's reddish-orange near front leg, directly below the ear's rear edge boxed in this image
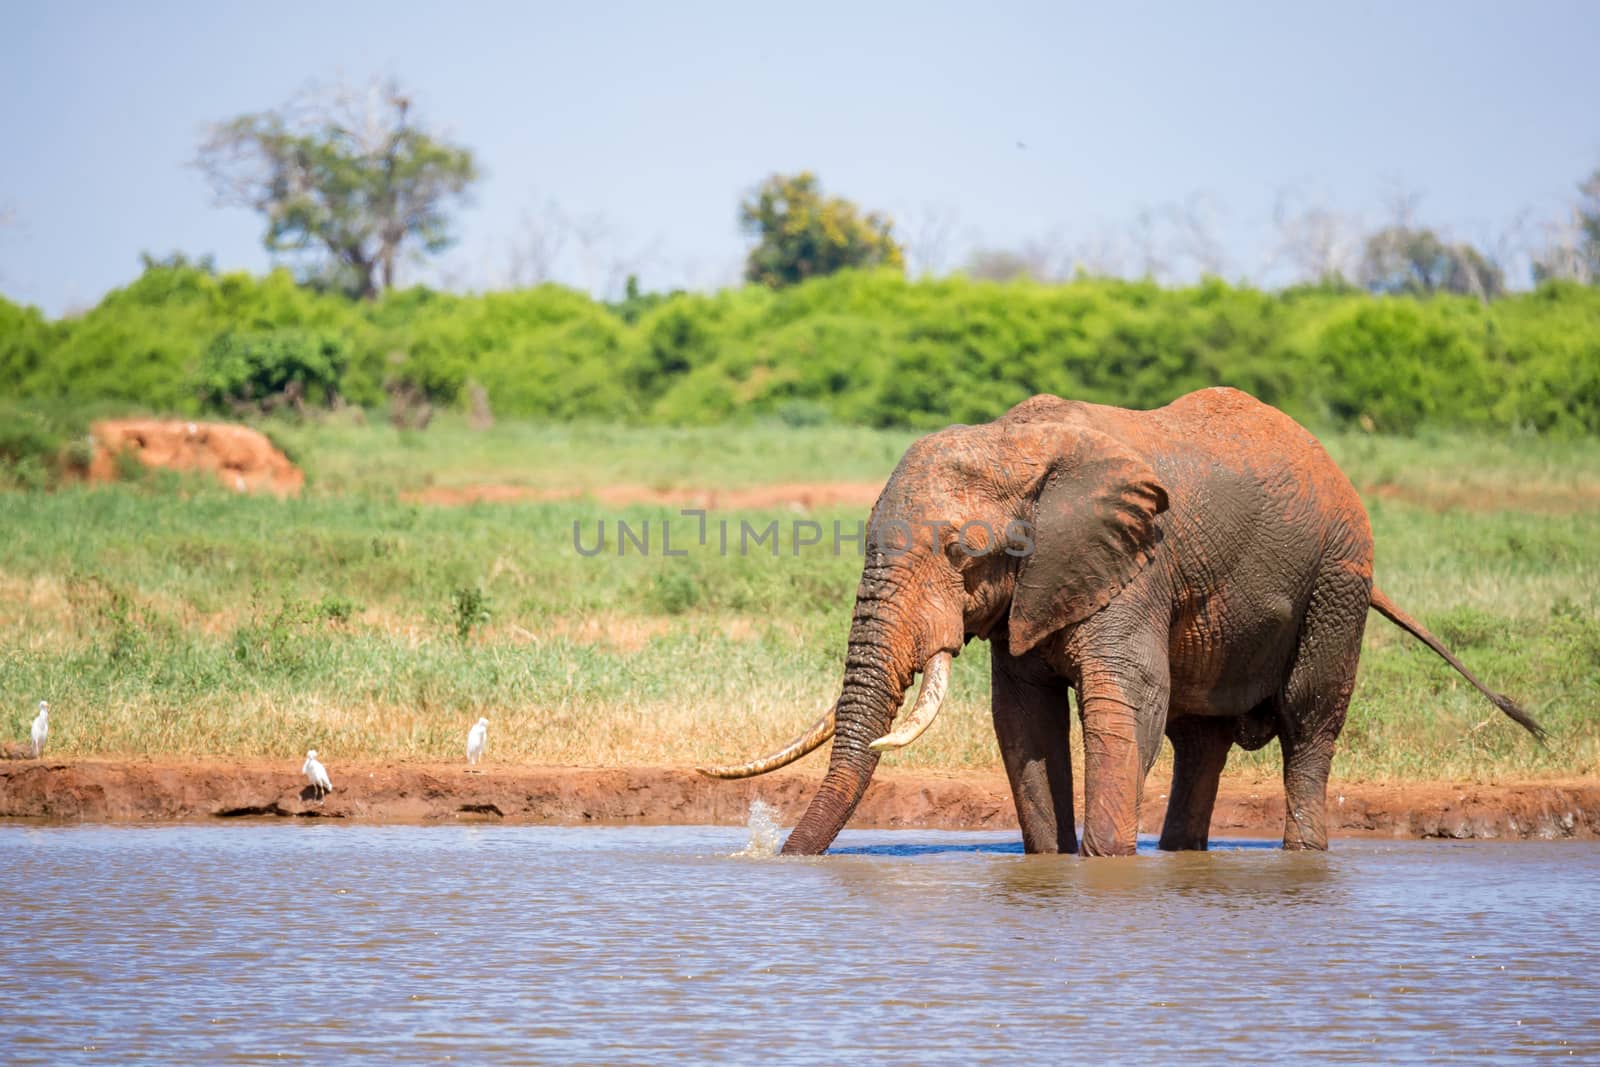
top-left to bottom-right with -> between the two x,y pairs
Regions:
1078,640 -> 1171,856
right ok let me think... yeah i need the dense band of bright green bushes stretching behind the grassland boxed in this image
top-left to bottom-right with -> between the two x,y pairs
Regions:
0,259 -> 1600,437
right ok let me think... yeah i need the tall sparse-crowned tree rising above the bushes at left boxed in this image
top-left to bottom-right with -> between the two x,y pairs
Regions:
195,82 -> 477,298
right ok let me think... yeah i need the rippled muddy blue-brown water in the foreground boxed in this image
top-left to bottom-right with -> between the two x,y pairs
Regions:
0,824 -> 1600,1064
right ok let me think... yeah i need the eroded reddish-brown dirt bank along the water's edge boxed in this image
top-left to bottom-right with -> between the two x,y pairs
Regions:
0,758 -> 1600,840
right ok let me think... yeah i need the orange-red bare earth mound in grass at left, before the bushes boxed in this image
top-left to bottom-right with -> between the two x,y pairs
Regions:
88,419 -> 306,496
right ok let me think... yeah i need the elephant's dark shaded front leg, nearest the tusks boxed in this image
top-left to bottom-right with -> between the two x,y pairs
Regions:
989,637 -> 1078,853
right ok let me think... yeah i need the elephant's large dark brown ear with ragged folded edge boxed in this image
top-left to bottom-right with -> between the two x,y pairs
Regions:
1010,427 -> 1166,656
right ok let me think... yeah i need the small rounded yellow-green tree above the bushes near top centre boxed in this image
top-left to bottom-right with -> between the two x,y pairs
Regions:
739,171 -> 906,288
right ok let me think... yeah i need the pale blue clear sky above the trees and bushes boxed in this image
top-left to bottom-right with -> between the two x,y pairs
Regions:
0,0 -> 1600,314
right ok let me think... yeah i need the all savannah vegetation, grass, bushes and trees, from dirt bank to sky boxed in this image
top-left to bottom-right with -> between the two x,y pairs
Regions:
0,73 -> 1600,777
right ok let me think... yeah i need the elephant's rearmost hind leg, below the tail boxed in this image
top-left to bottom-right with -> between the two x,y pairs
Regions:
1278,565 -> 1371,849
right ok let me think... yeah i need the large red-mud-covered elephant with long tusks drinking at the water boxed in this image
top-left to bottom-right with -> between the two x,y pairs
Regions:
701,387 -> 1544,856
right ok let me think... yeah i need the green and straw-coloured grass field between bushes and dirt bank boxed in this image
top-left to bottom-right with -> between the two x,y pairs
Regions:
0,419 -> 1600,779
